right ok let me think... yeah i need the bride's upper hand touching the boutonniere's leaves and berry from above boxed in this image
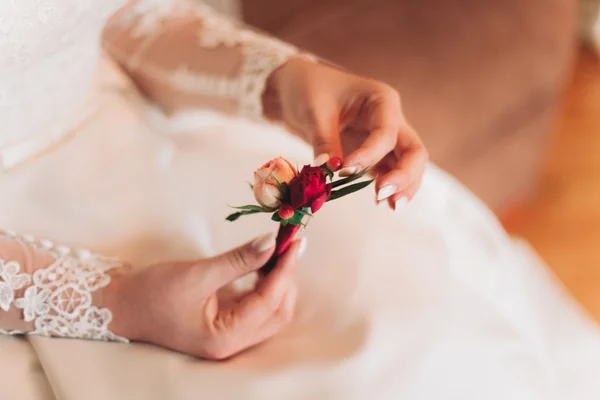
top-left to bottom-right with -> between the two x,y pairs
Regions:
264,58 -> 428,209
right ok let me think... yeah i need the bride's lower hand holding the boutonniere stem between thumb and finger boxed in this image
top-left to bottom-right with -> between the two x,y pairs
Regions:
105,231 -> 305,360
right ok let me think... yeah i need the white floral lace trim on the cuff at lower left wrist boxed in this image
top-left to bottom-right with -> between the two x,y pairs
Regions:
0,231 -> 128,342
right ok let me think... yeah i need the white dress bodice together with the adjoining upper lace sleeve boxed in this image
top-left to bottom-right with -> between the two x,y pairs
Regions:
0,0 -> 296,173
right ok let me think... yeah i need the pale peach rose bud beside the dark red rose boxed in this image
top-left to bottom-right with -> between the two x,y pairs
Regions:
253,157 -> 298,210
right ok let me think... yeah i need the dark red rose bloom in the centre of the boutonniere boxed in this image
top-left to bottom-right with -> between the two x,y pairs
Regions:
288,165 -> 331,213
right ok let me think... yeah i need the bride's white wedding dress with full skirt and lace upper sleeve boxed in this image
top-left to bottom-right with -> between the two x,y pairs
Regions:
0,0 -> 600,400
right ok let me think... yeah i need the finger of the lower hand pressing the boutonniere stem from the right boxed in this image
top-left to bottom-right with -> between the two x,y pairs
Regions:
217,238 -> 306,335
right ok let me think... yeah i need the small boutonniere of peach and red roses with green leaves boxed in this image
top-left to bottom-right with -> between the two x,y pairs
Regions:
227,157 -> 373,273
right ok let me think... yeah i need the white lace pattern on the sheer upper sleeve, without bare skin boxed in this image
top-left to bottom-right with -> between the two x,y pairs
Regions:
108,0 -> 298,119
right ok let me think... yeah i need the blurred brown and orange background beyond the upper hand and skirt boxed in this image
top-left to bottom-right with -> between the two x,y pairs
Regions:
217,0 -> 600,321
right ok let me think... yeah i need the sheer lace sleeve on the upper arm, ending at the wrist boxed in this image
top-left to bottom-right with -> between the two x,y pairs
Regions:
104,0 -> 304,119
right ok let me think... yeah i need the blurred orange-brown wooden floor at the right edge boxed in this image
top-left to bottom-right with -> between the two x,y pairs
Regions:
504,46 -> 600,321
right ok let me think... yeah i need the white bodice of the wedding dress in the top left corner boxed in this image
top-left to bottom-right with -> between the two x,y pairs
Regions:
0,0 -> 124,152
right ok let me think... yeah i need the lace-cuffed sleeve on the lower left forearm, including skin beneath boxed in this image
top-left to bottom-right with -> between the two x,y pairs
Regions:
0,231 -> 127,342
